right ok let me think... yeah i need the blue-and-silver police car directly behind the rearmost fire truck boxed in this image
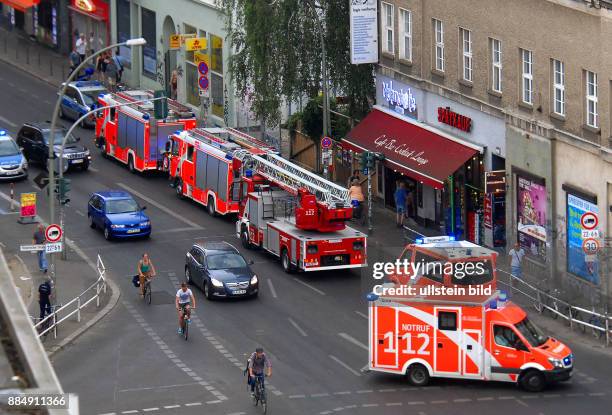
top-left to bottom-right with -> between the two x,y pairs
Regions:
59,81 -> 108,128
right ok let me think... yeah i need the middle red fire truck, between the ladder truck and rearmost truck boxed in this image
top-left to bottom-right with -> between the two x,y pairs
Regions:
163,128 -> 272,216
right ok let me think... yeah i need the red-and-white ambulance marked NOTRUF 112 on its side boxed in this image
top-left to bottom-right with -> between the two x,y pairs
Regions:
368,240 -> 574,392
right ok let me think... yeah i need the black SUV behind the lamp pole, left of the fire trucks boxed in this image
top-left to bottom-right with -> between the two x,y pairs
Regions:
17,122 -> 91,172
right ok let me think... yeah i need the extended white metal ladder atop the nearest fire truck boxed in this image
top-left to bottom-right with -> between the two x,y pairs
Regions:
244,153 -> 351,207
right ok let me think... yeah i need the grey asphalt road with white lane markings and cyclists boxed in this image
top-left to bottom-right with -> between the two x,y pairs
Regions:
0,59 -> 612,415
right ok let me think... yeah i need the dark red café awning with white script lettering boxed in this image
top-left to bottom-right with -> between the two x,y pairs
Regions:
342,107 -> 482,189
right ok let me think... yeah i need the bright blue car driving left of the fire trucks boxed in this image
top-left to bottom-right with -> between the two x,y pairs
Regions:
87,190 -> 151,240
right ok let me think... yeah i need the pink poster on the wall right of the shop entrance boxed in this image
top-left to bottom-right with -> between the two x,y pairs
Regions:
516,176 -> 546,261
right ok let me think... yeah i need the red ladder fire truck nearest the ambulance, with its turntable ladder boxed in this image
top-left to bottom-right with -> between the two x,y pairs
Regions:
236,152 -> 367,272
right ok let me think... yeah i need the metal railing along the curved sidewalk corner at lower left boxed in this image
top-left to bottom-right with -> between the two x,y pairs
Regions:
34,255 -> 106,338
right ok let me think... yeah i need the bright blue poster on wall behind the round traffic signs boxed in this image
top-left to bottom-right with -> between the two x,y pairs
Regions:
567,193 -> 599,284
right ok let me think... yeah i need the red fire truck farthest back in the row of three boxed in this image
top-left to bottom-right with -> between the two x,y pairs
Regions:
96,91 -> 196,172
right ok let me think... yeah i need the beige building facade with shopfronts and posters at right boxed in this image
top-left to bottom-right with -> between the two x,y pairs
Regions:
370,0 -> 612,300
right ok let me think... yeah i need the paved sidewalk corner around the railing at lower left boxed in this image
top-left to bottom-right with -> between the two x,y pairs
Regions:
0,213 -> 119,354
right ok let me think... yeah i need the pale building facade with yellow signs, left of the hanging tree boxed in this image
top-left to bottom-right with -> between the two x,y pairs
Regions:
110,0 -> 237,126
